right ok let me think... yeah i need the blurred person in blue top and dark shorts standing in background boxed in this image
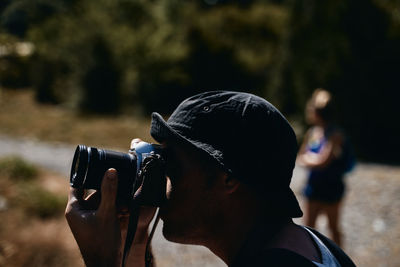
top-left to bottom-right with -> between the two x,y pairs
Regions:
297,89 -> 352,246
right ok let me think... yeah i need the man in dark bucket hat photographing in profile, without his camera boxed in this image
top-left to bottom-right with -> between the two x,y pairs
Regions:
66,91 -> 354,266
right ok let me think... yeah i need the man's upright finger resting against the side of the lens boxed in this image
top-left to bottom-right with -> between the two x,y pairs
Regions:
98,169 -> 118,216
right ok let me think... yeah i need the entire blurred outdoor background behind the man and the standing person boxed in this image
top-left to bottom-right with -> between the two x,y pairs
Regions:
0,0 -> 400,266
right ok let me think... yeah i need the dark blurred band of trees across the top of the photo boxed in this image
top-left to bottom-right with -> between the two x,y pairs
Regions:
0,0 -> 400,164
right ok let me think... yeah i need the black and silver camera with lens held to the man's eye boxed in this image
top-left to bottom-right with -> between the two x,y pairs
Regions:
70,142 -> 166,206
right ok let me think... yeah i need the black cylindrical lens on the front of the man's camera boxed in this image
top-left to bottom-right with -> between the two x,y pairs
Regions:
70,145 -> 137,200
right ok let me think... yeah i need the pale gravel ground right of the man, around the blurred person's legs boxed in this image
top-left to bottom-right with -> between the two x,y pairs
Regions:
293,163 -> 400,267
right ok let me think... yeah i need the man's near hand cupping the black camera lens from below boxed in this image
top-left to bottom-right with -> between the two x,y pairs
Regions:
65,169 -> 121,267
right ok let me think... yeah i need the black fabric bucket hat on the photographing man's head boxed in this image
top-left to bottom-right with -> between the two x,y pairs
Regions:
150,91 -> 303,217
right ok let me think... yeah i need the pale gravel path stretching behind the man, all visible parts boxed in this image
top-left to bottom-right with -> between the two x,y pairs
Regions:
0,136 -> 400,267
